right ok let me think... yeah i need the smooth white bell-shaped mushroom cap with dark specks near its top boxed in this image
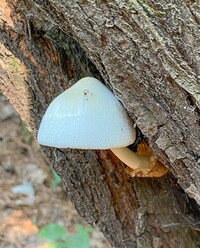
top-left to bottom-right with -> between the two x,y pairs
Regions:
37,77 -> 136,149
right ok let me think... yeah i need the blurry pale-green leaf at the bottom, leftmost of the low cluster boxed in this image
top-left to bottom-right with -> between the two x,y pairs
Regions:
39,224 -> 67,240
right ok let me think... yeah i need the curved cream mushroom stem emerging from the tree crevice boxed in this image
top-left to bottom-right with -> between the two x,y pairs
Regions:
110,147 -> 150,169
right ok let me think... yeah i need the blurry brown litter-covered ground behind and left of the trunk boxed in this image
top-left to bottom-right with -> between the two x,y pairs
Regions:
0,95 -> 110,248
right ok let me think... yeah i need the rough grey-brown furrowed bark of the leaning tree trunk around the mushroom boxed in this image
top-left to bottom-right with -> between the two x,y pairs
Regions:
0,0 -> 200,248
